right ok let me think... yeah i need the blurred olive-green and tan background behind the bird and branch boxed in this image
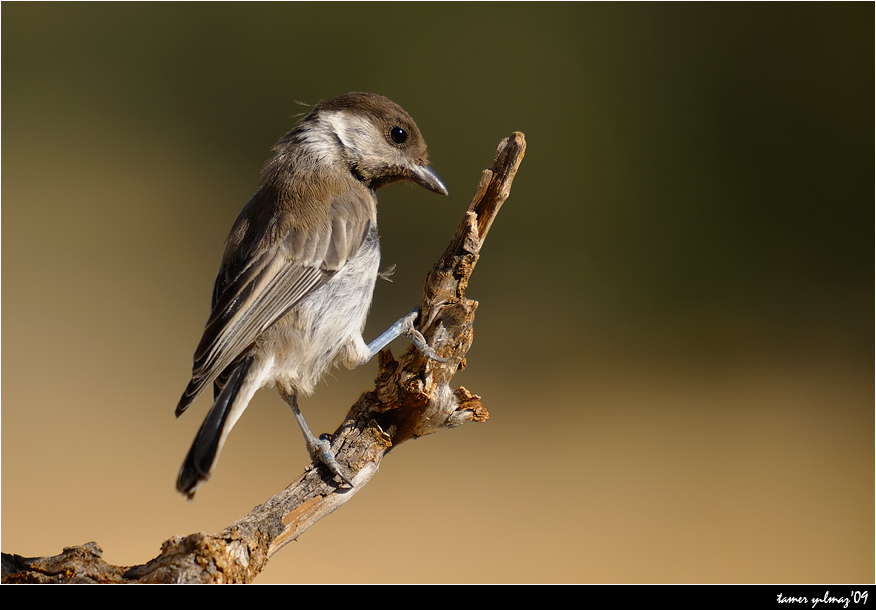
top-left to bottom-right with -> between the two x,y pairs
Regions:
2,3 -> 874,583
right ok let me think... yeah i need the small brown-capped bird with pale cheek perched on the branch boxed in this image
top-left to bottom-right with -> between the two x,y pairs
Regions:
176,93 -> 448,500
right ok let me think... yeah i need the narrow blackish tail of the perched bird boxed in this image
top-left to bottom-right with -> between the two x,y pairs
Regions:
176,357 -> 252,500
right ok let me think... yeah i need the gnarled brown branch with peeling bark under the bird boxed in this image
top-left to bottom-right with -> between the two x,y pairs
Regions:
3,132 -> 526,583
